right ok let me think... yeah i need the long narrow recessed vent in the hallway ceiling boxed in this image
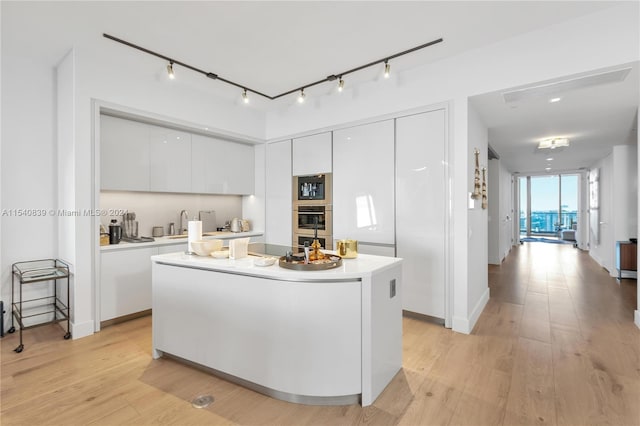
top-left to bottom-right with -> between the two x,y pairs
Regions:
502,67 -> 631,103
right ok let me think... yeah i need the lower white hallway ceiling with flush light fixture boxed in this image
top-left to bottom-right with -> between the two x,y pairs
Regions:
470,62 -> 640,174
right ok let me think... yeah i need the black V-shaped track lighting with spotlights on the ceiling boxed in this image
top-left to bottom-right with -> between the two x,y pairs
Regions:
102,33 -> 443,103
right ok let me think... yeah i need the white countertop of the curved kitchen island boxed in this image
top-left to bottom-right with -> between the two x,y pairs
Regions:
151,251 -> 402,281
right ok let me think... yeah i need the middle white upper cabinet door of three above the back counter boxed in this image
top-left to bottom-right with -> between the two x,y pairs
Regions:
149,126 -> 191,192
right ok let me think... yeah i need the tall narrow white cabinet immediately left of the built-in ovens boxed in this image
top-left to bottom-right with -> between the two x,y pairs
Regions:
265,140 -> 293,246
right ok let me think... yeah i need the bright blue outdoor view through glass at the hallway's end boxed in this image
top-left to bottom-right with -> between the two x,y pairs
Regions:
519,175 -> 579,236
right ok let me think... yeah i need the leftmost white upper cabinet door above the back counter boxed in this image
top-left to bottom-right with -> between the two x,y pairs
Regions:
100,115 -> 149,191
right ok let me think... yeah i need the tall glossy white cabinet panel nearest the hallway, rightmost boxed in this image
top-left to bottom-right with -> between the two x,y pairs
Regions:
396,110 -> 447,318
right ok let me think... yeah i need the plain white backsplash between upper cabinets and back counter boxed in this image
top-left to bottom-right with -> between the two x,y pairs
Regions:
100,191 -> 242,237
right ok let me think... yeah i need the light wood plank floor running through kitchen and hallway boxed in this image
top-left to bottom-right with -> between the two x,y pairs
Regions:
0,243 -> 640,426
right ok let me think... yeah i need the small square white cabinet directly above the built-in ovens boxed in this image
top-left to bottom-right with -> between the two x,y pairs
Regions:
293,132 -> 332,176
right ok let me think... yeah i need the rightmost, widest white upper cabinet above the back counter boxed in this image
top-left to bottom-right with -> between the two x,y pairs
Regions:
190,134 -> 255,195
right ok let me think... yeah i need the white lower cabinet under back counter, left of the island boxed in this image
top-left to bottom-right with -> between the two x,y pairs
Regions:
100,247 -> 158,321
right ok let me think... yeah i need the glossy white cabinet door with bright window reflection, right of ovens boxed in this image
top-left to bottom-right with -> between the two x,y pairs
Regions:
333,120 -> 395,246
